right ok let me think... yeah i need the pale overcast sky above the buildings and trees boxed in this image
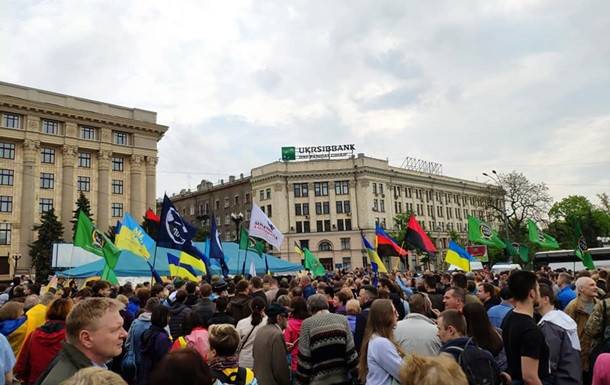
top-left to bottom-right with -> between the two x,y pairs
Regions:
0,0 -> 610,203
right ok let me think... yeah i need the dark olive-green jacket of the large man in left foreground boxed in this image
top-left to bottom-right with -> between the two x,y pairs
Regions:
35,341 -> 93,385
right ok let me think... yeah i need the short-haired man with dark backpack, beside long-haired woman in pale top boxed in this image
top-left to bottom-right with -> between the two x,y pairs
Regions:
437,309 -> 502,385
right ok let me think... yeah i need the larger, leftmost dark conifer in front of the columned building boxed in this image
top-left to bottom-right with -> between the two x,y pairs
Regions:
29,208 -> 64,282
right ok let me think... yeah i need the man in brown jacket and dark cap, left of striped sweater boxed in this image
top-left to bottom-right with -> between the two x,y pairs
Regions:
252,302 -> 292,385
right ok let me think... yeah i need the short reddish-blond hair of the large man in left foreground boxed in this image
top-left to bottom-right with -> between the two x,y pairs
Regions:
66,297 -> 125,345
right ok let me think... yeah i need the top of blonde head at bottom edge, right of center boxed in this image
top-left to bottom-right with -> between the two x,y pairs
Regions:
399,354 -> 468,385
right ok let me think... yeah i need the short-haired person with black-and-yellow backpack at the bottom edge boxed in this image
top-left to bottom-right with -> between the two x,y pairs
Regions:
208,324 -> 258,385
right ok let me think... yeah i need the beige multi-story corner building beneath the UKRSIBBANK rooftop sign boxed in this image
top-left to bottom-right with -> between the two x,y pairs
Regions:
250,154 -> 502,268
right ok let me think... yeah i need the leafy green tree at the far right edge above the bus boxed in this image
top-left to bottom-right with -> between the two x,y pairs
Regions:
547,195 -> 610,249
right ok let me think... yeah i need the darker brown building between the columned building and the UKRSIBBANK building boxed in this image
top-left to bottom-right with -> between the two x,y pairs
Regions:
165,174 -> 252,241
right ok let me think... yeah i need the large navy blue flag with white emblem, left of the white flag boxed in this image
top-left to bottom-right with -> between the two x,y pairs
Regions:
158,195 -> 211,280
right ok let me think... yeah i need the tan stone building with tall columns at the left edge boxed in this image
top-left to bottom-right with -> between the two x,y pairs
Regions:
0,82 -> 168,274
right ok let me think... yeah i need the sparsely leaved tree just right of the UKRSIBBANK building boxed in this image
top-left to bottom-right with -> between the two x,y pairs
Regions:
485,171 -> 553,242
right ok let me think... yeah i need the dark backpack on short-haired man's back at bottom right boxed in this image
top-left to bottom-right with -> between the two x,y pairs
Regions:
445,338 -> 502,385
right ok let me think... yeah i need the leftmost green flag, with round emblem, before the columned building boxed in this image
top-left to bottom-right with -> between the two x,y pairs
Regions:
74,211 -> 121,284
